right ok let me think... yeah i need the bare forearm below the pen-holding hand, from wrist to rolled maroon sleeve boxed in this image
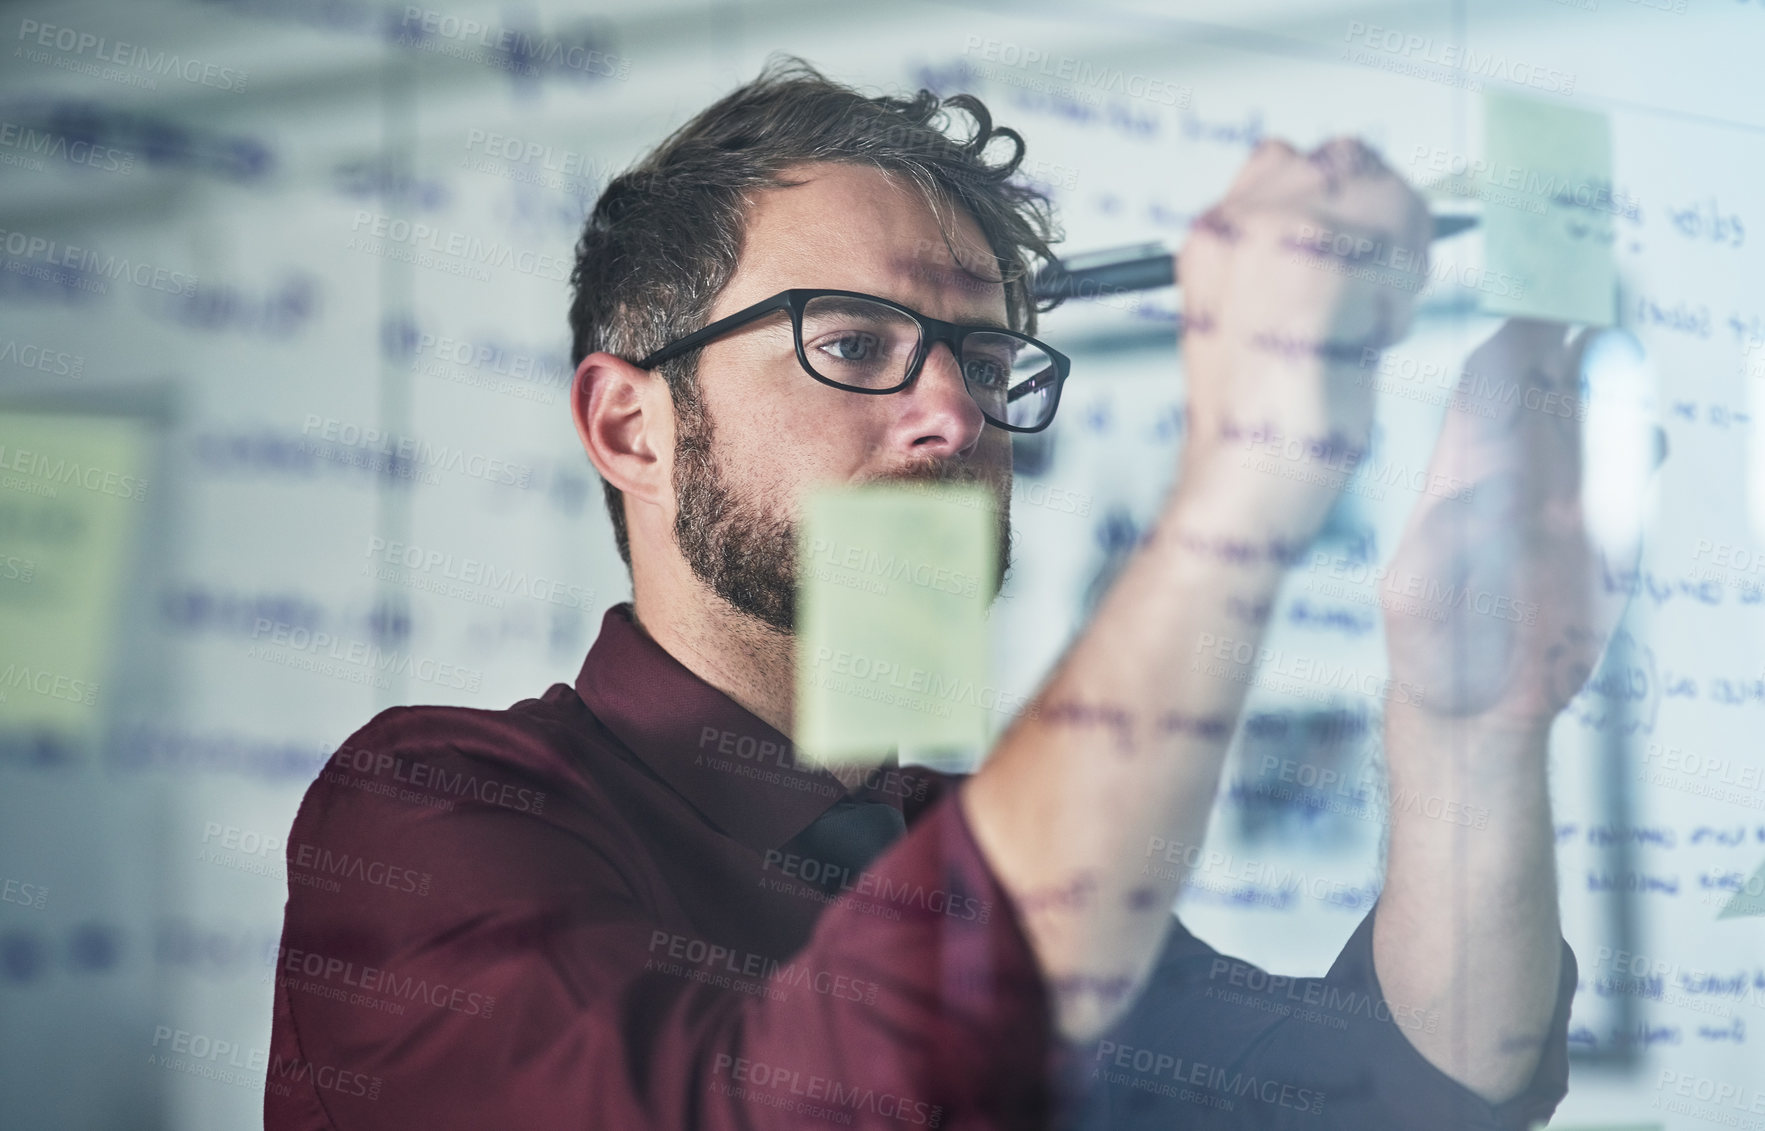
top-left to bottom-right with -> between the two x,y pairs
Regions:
964,487 -> 1304,1039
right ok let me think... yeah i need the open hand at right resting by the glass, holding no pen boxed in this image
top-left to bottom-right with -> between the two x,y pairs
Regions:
1386,319 -> 1663,732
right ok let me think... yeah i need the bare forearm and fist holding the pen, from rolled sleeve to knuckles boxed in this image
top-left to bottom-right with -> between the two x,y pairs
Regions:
964,141 -> 1428,1039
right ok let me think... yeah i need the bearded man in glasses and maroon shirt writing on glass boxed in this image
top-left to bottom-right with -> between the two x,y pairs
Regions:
265,55 -> 1615,1129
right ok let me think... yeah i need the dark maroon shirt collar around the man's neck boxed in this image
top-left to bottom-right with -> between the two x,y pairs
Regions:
575,602 -> 902,852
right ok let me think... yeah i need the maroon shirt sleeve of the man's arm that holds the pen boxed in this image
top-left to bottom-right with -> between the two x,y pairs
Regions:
265,720 -> 1054,1131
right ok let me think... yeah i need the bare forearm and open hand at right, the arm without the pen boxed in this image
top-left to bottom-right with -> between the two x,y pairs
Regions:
1373,321 -> 1664,1101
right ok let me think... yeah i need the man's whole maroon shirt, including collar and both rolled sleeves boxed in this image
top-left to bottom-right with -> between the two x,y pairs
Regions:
265,603 -> 1574,1131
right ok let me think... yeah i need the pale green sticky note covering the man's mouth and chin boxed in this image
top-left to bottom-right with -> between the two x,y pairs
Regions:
792,483 -> 999,766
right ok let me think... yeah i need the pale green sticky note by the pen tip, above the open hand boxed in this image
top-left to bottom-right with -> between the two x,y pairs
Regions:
1479,94 -> 1619,326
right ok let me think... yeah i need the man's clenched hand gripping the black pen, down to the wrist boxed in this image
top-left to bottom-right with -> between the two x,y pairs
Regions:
1179,138 -> 1431,540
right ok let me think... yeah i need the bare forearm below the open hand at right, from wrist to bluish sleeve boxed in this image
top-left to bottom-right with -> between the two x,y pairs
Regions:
1373,711 -> 1562,1103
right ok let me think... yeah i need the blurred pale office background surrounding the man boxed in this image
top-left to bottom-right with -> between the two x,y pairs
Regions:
0,0 -> 1765,1129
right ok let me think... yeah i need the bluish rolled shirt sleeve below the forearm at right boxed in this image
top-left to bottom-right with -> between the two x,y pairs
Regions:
1073,905 -> 1576,1131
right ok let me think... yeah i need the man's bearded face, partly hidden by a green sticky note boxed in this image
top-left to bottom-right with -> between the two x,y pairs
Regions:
672,164 -> 1011,633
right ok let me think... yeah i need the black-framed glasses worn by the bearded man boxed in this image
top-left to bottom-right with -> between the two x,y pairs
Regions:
637,288 -> 1073,432
